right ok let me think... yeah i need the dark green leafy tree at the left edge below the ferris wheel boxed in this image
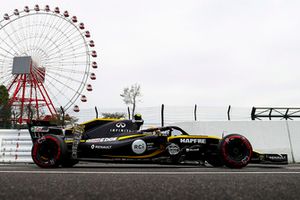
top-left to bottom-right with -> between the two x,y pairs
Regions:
0,85 -> 11,128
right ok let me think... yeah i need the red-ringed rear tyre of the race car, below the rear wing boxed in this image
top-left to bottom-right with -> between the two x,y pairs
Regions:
31,135 -> 67,168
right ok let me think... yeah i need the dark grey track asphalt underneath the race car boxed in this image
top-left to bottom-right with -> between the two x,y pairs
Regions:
0,163 -> 300,200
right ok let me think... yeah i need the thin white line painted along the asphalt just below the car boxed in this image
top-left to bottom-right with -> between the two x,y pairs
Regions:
0,171 -> 300,175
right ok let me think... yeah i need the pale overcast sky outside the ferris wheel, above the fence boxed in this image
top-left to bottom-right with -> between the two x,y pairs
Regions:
0,0 -> 300,107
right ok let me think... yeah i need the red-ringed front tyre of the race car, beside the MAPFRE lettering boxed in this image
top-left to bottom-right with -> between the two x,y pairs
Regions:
219,134 -> 253,168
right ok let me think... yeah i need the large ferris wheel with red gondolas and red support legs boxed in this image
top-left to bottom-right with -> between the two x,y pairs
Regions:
0,5 -> 98,123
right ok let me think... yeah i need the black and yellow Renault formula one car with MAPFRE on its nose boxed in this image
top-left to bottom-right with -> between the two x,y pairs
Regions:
29,116 -> 288,168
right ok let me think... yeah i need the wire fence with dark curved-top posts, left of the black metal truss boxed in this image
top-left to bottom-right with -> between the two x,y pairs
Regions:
69,105 -> 252,126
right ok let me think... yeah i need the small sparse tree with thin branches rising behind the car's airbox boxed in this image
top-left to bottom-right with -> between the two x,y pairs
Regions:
120,83 -> 142,116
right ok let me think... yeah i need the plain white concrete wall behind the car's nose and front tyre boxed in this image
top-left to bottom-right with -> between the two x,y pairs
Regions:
174,121 -> 300,163
